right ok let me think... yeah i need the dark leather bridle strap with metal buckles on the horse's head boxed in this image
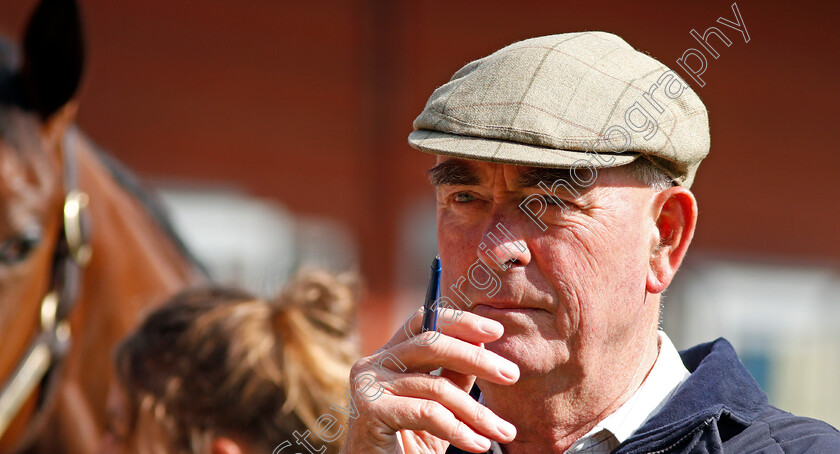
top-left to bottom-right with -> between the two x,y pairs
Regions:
0,127 -> 92,452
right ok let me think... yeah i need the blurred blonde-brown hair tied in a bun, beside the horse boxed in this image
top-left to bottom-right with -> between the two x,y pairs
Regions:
116,271 -> 357,452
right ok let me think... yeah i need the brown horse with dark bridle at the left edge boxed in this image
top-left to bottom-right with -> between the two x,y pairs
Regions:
0,0 -> 203,453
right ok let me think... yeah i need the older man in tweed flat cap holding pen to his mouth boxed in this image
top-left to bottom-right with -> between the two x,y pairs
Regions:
336,32 -> 840,454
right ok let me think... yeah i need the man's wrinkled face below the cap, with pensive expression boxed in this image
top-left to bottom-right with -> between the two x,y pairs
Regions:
430,157 -> 659,386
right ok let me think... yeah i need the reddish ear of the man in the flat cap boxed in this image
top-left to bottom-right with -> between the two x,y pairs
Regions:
647,186 -> 697,293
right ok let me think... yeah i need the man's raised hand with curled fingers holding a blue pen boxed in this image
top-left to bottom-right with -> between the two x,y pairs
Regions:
342,309 -> 519,454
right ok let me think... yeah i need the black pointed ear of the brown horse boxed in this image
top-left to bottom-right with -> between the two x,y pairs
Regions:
21,0 -> 84,120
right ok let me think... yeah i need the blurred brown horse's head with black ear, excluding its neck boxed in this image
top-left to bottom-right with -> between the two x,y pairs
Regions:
0,0 -> 84,451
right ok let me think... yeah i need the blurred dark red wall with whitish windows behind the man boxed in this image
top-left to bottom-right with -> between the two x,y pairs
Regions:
0,0 -> 840,425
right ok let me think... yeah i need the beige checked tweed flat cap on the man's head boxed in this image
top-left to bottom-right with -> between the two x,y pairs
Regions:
408,32 -> 709,187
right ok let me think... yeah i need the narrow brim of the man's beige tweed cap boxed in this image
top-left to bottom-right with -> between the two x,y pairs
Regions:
408,129 -> 639,169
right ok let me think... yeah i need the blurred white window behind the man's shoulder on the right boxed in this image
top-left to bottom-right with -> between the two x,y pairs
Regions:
663,257 -> 840,426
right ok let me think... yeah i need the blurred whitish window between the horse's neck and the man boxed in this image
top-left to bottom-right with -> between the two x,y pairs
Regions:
158,185 -> 358,298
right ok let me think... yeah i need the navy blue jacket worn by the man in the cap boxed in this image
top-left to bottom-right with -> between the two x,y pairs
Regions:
446,339 -> 840,454
